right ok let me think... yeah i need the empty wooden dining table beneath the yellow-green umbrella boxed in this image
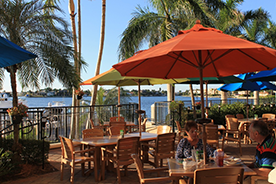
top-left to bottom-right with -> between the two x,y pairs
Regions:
73,132 -> 157,181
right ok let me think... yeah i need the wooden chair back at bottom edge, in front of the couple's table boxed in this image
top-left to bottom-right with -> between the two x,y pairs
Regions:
194,167 -> 244,184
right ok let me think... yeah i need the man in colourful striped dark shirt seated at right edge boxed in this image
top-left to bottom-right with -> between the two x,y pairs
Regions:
244,120 -> 276,183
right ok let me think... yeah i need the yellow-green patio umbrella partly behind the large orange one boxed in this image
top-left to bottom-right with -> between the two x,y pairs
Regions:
80,68 -> 189,133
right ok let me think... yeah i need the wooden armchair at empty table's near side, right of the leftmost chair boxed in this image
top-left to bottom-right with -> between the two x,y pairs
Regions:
102,137 -> 140,184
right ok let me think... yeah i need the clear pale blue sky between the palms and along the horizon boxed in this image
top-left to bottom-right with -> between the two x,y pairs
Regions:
3,0 -> 276,92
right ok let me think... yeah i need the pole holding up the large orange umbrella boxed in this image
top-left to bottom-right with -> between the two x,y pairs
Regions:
199,67 -> 207,164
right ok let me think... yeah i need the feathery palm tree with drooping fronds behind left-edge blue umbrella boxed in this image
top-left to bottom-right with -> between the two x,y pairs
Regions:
0,0 -> 80,152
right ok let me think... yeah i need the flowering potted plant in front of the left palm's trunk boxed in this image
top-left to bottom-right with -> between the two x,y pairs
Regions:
7,103 -> 28,124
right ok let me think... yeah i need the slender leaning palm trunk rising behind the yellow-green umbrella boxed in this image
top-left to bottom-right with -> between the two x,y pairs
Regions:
86,0 -> 106,127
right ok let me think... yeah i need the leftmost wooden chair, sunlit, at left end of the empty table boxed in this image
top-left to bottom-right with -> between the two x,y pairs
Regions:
59,136 -> 97,183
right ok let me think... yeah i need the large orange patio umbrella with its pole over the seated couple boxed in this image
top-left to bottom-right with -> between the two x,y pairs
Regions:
113,20 -> 276,163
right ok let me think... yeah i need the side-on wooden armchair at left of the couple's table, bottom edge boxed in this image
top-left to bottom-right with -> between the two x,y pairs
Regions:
131,154 -> 178,184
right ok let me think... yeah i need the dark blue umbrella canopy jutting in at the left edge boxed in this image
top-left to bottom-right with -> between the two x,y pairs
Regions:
0,36 -> 37,68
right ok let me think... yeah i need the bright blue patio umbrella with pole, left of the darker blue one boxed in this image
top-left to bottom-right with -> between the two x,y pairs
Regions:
218,73 -> 276,118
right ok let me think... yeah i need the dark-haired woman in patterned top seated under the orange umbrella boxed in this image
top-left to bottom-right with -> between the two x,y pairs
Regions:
175,122 -> 214,159
